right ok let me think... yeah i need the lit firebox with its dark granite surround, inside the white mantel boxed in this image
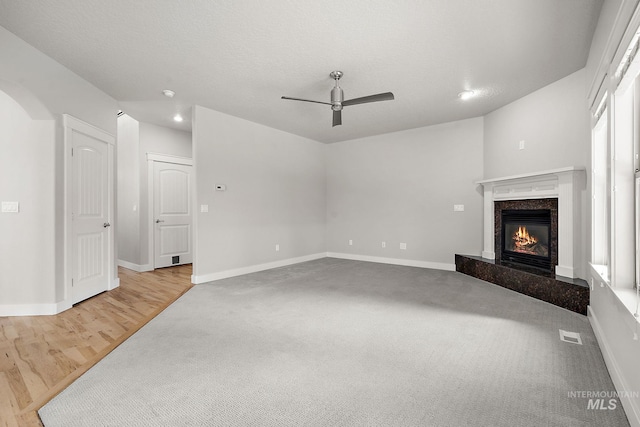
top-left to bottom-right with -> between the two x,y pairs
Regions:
494,198 -> 558,272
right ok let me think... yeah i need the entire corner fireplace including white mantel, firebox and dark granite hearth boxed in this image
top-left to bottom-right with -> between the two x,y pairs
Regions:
456,167 -> 589,315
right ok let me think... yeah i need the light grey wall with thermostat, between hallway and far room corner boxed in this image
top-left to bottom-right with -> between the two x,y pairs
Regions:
193,106 -> 326,283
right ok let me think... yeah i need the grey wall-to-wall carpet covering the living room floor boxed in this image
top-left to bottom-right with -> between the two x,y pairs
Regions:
39,258 -> 628,427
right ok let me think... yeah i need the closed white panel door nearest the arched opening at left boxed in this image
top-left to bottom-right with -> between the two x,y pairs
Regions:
71,130 -> 111,304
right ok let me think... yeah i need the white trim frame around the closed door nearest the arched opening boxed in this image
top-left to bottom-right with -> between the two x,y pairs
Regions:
60,114 -> 120,311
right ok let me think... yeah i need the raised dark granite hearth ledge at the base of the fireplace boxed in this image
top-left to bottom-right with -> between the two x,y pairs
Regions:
456,254 -> 589,315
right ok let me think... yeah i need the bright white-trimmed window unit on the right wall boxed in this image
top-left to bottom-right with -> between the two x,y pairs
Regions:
591,32 -> 640,290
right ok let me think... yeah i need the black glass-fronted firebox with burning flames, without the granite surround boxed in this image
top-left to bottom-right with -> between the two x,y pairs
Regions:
501,209 -> 551,270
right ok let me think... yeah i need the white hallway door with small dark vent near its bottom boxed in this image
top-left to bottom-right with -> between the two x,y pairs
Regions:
153,162 -> 193,268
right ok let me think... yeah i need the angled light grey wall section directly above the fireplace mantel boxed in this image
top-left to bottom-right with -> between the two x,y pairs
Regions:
484,69 -> 591,179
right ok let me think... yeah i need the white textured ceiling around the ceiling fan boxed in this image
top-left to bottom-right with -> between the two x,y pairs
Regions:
0,0 -> 602,142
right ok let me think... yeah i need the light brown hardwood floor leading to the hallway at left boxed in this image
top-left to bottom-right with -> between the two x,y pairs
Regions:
0,265 -> 192,426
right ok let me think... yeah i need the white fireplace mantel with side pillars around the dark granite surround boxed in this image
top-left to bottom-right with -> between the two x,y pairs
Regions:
476,167 -> 586,278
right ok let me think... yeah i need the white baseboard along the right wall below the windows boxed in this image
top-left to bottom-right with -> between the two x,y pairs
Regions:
587,306 -> 640,427
